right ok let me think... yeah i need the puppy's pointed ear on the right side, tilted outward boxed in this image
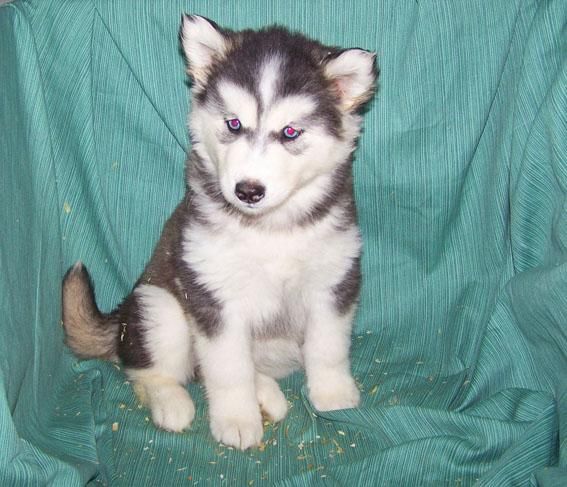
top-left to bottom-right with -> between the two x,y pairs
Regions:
323,49 -> 378,112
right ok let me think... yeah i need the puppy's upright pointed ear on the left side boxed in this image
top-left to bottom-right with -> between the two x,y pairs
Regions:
180,14 -> 229,85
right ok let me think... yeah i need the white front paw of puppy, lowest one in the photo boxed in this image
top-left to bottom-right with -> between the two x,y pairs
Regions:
211,411 -> 264,450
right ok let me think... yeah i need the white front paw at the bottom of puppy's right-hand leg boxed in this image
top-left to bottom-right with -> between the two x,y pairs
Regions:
309,374 -> 360,411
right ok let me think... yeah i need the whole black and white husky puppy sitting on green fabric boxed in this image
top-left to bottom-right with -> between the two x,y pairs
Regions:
63,15 -> 377,450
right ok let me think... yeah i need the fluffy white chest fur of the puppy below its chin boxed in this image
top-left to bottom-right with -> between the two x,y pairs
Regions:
183,214 -> 360,333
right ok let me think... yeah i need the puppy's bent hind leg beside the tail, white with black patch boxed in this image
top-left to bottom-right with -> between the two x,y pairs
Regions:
119,284 -> 195,432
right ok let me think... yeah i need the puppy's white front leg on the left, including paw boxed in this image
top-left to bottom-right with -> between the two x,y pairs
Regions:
197,320 -> 263,450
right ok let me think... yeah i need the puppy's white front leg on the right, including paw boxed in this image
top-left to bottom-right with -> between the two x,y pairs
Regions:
303,299 -> 360,411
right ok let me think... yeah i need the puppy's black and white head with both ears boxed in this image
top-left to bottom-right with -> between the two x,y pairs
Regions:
182,16 -> 376,215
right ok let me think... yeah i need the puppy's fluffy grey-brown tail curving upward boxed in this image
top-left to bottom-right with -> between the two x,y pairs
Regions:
63,262 -> 118,360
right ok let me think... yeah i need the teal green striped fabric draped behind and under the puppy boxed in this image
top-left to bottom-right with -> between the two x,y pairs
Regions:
0,0 -> 567,486
